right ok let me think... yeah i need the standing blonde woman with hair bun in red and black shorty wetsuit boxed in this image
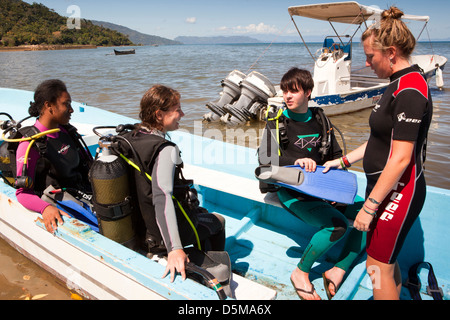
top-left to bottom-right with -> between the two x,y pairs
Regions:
326,7 -> 433,299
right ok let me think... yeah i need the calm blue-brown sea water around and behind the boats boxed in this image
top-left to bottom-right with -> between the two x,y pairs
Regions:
0,42 -> 450,299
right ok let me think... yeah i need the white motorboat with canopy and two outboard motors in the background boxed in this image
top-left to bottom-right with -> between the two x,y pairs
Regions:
204,1 -> 447,125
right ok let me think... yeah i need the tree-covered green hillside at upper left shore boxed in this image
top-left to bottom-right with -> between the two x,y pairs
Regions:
0,0 -> 133,47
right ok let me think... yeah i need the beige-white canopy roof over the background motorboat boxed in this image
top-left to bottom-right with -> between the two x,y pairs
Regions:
288,1 -> 430,24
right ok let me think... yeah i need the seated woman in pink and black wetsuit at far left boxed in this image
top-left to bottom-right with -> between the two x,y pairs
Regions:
16,79 -> 90,232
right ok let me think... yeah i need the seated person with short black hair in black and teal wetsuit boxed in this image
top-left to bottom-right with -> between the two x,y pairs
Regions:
259,68 -> 364,300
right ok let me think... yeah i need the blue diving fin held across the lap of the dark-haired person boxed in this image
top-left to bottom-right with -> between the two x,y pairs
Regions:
255,165 -> 358,204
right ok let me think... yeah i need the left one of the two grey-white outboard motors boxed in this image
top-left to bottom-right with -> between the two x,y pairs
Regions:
203,70 -> 245,122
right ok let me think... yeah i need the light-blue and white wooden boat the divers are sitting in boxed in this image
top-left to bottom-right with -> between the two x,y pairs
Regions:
0,88 -> 450,304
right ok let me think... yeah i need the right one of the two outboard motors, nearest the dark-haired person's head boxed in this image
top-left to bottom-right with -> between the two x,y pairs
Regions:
220,71 -> 276,125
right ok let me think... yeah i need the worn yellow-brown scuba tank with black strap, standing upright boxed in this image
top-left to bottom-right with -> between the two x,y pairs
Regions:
89,140 -> 136,249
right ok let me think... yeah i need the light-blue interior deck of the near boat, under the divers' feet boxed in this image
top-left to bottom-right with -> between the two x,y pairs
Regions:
185,161 -> 450,300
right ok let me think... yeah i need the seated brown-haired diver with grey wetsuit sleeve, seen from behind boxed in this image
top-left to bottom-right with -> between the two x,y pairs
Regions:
126,85 -> 225,281
